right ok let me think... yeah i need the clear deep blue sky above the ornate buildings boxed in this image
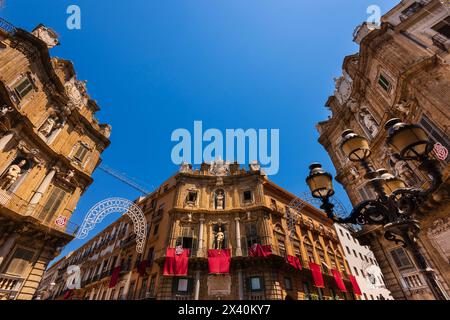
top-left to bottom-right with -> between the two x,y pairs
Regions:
0,0 -> 398,262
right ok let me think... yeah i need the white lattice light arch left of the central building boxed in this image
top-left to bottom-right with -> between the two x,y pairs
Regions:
76,198 -> 147,253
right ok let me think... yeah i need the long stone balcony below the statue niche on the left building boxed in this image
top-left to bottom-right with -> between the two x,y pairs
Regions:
0,189 -> 79,236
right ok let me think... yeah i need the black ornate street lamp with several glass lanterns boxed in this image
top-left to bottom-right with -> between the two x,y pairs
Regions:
306,119 -> 448,300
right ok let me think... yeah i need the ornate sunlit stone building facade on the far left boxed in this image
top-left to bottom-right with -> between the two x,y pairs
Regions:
0,19 -> 111,299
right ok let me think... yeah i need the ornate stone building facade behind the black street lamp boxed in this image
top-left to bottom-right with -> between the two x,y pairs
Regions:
317,0 -> 450,299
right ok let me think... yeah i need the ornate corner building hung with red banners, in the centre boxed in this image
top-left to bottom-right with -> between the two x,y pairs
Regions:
39,160 -> 358,300
